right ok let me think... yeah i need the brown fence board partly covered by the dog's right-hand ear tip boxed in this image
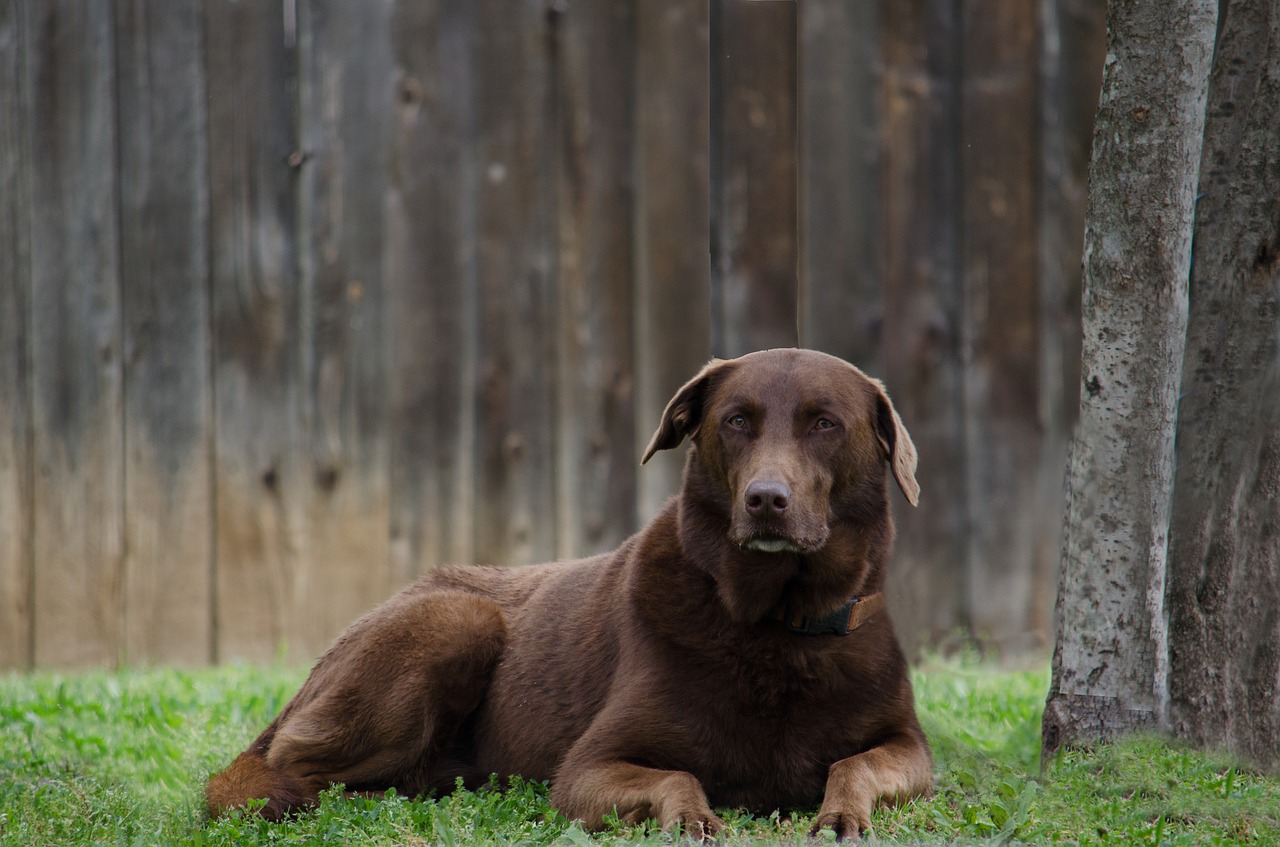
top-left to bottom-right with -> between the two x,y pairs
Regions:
881,1 -> 968,651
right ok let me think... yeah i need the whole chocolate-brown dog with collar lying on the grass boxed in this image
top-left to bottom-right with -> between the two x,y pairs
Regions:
206,349 -> 932,838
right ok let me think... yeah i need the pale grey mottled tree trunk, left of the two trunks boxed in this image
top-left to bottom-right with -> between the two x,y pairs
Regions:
1043,0 -> 1217,755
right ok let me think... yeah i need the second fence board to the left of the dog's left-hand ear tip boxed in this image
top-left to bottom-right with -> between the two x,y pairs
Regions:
472,0 -> 557,564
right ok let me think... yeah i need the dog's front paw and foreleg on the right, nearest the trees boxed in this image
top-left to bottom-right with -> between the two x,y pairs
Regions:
810,731 -> 933,841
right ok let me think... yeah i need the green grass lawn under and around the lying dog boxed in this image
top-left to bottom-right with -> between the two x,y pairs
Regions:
0,660 -> 1280,847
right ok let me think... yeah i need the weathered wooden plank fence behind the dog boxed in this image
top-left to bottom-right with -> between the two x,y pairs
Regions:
0,0 -> 1102,668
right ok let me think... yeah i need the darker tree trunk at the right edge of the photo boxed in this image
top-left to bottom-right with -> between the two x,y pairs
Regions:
1166,0 -> 1280,768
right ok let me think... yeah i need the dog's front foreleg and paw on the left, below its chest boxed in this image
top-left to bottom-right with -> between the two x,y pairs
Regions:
550,761 -> 724,841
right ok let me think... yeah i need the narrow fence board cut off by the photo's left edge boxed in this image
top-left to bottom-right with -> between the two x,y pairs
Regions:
0,0 -> 33,668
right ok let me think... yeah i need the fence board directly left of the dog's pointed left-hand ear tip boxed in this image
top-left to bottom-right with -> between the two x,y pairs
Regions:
548,0 -> 637,555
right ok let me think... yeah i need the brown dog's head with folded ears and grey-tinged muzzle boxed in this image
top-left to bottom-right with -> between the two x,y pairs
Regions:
644,349 -> 920,554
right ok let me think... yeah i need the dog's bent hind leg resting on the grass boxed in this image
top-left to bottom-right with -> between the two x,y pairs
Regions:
205,591 -> 506,819
